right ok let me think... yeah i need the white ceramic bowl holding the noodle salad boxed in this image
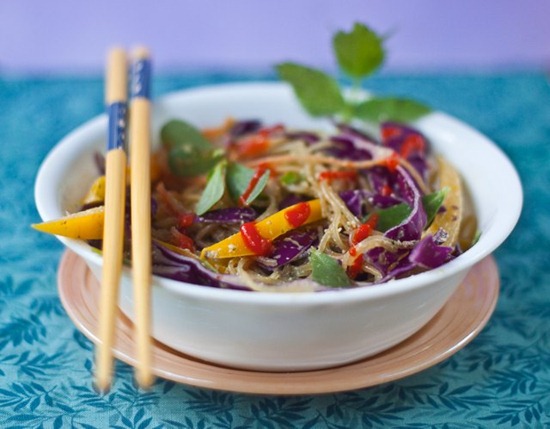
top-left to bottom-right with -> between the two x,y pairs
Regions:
35,83 -> 522,371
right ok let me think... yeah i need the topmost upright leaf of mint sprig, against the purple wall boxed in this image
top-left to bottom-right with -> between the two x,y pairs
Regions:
332,23 -> 385,79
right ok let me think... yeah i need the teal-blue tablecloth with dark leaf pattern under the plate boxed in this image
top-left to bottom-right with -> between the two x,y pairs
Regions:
0,72 -> 550,429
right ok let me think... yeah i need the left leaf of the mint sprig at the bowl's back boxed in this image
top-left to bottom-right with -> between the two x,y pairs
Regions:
277,63 -> 345,116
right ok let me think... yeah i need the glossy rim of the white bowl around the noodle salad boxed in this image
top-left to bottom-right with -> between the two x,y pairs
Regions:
34,81 -> 523,305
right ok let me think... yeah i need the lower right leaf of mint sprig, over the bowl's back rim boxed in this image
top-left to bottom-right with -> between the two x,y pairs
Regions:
354,97 -> 432,123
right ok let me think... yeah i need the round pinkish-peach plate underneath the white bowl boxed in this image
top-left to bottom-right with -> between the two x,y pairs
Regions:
58,251 -> 500,395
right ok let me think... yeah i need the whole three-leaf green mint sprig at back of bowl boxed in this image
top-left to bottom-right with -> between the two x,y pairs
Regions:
276,23 -> 431,123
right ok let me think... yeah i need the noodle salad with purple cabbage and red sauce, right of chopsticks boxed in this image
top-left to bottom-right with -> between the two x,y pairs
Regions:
142,120 -> 475,290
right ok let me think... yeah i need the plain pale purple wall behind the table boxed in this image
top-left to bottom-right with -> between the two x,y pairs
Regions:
0,0 -> 550,73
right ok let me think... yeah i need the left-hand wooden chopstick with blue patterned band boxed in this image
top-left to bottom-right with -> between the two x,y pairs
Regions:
96,48 -> 128,391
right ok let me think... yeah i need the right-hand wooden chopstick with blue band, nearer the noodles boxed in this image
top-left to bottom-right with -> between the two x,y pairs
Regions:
130,48 -> 154,388
